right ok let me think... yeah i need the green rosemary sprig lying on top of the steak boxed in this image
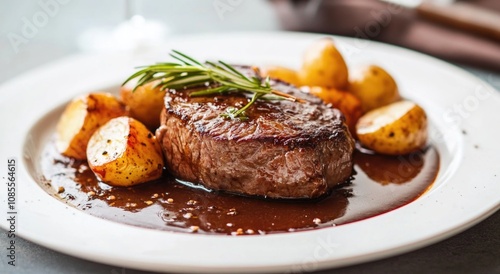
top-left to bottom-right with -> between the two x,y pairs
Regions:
123,50 -> 304,119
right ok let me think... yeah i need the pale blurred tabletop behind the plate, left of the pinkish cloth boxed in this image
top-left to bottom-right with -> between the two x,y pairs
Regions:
0,0 -> 279,83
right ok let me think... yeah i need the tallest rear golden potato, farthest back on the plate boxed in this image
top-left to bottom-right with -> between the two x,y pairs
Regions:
299,38 -> 348,89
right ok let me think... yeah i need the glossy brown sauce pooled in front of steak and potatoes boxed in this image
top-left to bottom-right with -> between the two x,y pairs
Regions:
41,139 -> 439,235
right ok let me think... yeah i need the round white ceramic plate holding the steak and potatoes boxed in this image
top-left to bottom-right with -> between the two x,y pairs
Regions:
0,33 -> 500,272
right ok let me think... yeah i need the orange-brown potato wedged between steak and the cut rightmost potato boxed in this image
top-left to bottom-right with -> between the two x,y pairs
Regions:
309,87 -> 363,135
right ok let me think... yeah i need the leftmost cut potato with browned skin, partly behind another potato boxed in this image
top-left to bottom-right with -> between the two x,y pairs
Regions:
56,93 -> 127,160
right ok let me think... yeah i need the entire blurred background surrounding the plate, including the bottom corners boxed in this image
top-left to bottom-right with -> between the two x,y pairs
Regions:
0,0 -> 500,273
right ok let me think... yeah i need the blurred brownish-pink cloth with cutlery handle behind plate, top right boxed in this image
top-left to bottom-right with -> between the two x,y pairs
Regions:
271,0 -> 500,72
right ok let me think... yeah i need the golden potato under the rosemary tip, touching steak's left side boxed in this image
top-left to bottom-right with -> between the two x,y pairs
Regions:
120,81 -> 165,130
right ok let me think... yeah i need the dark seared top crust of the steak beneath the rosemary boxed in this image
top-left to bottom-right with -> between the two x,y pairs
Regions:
165,79 -> 347,147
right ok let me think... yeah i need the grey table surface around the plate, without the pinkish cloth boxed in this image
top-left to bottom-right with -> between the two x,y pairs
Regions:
0,0 -> 500,274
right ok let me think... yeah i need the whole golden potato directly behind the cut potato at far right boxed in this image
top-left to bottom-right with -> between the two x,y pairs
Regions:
349,65 -> 401,112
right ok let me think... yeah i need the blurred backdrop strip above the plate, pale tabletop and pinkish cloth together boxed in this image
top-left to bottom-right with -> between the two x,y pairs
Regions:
0,0 -> 500,85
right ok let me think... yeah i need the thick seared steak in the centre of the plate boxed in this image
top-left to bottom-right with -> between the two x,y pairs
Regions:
156,71 -> 354,198
